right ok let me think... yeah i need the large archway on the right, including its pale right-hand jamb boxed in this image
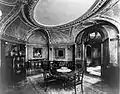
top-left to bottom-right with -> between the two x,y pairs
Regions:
75,20 -> 119,79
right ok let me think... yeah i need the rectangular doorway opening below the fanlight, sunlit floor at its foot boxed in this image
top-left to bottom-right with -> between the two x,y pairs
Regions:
86,42 -> 102,76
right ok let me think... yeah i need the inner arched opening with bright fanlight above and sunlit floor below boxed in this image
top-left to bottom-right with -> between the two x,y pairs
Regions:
82,27 -> 104,76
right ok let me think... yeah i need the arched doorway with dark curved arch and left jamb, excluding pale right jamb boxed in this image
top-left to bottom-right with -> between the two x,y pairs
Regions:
76,25 -> 106,76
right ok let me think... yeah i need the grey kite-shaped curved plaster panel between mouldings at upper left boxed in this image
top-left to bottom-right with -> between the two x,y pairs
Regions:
4,16 -> 33,40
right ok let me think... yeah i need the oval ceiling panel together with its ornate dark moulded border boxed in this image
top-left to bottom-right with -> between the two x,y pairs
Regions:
23,0 -> 110,29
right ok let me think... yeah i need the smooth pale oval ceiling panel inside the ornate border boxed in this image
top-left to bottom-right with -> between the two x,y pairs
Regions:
33,0 -> 96,26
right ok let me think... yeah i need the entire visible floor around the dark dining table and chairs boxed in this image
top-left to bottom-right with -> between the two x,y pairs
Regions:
0,74 -> 119,94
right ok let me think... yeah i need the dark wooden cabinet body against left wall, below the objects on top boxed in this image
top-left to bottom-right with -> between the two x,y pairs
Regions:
4,56 -> 26,84
